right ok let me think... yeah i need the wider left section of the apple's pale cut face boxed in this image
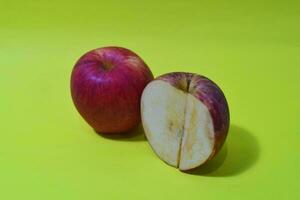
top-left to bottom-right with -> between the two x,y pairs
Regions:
141,81 -> 186,167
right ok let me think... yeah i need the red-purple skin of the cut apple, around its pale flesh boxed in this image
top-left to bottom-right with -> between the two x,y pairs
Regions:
156,72 -> 230,160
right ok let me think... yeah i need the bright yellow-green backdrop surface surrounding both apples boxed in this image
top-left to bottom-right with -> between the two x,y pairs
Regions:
0,0 -> 300,200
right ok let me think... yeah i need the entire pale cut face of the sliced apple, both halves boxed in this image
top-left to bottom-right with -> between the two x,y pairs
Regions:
141,80 -> 214,170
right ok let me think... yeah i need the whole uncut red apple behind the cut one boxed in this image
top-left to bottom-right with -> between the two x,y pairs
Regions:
71,46 -> 153,133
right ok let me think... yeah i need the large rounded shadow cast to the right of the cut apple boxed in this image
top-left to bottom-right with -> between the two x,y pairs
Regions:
186,125 -> 260,177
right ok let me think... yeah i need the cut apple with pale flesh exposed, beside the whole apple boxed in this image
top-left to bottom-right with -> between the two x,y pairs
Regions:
141,72 -> 229,171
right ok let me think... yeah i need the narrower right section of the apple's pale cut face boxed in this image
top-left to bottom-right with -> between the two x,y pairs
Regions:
179,94 -> 214,170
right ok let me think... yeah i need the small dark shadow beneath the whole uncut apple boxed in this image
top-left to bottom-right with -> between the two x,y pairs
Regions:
96,124 -> 147,142
